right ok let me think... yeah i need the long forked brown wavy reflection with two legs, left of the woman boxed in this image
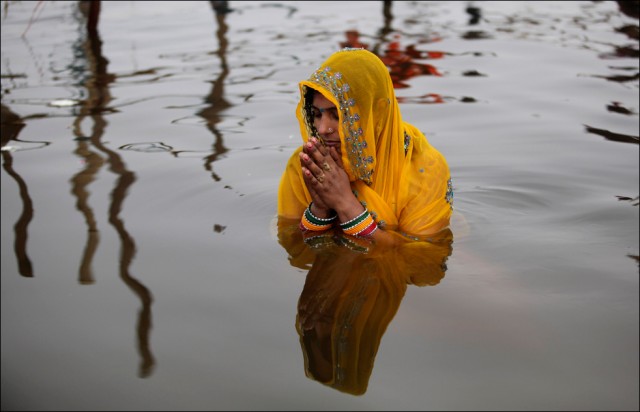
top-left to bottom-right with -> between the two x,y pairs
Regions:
71,1 -> 155,378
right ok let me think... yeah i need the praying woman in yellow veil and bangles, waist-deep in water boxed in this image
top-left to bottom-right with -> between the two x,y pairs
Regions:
278,48 -> 453,241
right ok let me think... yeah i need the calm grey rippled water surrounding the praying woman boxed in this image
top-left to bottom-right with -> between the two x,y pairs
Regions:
1,1 -> 639,410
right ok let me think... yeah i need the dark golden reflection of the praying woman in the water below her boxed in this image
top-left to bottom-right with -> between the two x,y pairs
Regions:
278,219 -> 453,395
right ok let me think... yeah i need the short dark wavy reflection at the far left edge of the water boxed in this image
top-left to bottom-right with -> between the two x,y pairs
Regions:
1,104 -> 33,278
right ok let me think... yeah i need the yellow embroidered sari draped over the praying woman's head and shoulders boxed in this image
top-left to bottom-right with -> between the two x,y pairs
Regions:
278,48 -> 453,236
